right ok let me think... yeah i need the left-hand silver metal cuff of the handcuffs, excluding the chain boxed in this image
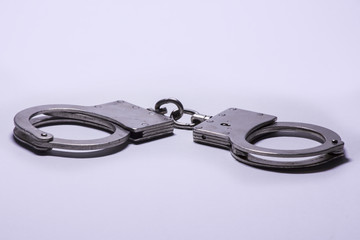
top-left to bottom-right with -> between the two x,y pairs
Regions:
14,101 -> 173,150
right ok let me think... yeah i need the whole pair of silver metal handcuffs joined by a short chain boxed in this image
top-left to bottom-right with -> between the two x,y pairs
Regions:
14,98 -> 344,170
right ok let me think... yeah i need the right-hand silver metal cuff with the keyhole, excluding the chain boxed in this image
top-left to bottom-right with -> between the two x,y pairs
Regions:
193,108 -> 344,168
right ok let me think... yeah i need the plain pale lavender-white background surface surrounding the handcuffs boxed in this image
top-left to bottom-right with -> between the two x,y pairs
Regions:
0,0 -> 360,240
